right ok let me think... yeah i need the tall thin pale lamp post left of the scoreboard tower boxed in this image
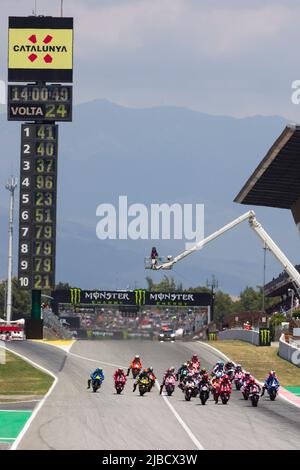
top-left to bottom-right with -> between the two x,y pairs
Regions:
5,176 -> 17,322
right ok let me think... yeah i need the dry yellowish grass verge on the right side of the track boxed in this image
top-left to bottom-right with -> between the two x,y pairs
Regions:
212,340 -> 300,387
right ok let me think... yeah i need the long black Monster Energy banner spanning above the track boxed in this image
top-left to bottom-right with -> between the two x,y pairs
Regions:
51,288 -> 211,307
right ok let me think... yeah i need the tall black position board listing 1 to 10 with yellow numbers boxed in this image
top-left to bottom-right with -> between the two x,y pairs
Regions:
19,124 -> 58,290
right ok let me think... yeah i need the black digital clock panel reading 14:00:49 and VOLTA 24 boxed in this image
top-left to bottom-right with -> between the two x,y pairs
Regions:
7,84 -> 72,122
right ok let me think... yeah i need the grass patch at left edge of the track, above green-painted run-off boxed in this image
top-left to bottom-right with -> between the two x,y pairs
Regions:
0,351 -> 53,395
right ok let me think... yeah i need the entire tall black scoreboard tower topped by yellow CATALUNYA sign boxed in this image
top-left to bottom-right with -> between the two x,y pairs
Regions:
7,16 -> 73,337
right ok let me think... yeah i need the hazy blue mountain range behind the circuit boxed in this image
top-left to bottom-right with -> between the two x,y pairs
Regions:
0,100 -> 300,295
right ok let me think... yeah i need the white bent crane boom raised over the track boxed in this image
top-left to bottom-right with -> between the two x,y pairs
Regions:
154,210 -> 300,294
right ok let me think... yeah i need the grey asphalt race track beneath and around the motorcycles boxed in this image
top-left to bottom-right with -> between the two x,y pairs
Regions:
6,340 -> 300,450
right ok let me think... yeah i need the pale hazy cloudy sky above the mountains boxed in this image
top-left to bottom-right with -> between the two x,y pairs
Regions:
0,0 -> 300,121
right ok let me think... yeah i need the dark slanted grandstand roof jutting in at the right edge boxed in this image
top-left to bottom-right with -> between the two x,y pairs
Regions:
234,124 -> 300,209
